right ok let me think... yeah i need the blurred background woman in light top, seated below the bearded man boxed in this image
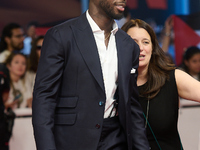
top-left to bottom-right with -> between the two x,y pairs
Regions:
5,53 -> 32,109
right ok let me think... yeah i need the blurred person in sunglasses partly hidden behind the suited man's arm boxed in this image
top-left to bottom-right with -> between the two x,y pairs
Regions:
26,35 -> 44,88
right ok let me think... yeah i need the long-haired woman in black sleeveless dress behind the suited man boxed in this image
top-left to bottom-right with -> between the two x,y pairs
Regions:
122,19 -> 200,150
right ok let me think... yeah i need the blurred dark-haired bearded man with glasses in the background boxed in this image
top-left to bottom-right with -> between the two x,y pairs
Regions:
0,23 -> 24,63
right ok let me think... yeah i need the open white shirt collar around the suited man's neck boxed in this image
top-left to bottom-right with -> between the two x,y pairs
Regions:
86,10 -> 118,34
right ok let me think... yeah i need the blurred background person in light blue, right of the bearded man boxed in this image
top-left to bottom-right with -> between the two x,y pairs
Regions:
21,21 -> 37,56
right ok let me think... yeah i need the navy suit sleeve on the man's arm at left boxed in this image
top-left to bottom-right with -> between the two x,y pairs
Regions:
32,28 -> 64,150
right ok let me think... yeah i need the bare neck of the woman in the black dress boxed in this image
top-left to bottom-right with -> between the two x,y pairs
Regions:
137,67 -> 148,86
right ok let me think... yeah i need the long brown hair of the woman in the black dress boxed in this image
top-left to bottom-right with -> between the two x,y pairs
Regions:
122,19 -> 175,99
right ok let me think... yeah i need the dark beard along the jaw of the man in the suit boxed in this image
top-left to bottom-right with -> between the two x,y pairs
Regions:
100,0 -> 124,20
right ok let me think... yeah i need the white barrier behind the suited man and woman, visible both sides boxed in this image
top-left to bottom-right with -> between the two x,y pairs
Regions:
9,100 -> 200,150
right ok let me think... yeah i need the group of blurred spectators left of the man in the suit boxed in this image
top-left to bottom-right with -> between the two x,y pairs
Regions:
0,23 -> 44,150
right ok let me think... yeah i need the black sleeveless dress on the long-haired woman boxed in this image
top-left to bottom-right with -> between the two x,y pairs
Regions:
138,70 -> 181,150
